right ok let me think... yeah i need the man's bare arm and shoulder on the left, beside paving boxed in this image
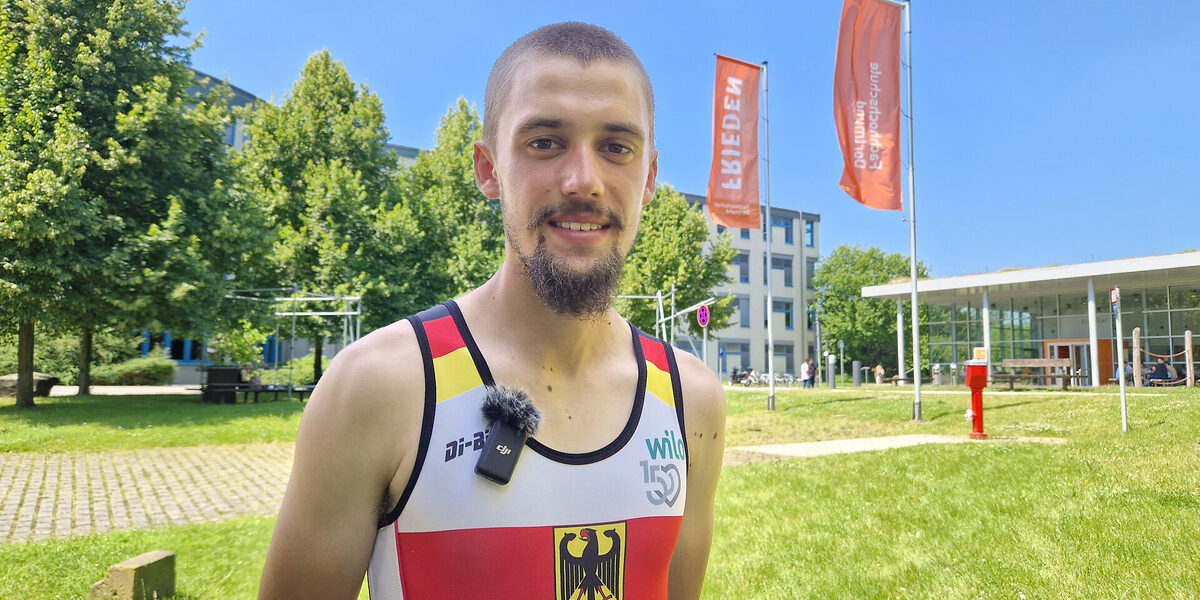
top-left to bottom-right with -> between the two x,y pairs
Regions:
258,323 -> 424,600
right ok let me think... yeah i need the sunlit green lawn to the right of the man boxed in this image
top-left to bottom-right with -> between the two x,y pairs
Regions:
704,390 -> 1200,599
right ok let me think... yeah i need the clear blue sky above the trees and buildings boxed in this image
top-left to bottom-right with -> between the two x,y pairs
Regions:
184,0 -> 1200,276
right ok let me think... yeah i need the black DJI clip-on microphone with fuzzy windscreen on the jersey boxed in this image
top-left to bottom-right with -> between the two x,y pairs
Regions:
475,385 -> 541,485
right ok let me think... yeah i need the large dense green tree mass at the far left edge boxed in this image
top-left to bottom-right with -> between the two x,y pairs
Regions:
0,0 -> 255,407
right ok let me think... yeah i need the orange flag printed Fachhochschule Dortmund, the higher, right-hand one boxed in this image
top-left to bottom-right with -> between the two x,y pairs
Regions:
833,0 -> 902,210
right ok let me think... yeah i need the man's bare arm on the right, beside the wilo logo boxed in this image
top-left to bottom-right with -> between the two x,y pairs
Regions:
668,350 -> 725,600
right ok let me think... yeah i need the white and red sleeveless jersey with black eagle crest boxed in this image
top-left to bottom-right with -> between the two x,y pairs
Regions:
367,302 -> 688,600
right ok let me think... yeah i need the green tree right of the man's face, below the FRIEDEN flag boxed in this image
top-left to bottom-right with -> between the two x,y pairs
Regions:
616,184 -> 737,337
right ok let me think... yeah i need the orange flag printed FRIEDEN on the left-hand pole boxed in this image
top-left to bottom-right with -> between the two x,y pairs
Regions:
707,55 -> 762,229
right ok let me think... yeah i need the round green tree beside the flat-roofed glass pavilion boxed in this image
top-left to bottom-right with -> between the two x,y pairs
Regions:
812,245 -> 929,365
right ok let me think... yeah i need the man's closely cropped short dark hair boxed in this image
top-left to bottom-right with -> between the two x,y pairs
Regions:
484,22 -> 654,148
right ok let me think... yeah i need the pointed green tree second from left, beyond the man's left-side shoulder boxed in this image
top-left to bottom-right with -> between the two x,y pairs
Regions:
236,50 -> 396,378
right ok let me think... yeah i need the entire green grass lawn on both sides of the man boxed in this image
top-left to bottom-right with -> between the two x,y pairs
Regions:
0,386 -> 1200,600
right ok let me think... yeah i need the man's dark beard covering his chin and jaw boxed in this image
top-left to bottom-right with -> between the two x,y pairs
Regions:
517,239 -> 625,319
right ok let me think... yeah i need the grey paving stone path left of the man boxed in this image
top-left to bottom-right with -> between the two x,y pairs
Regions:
0,444 -> 293,544
